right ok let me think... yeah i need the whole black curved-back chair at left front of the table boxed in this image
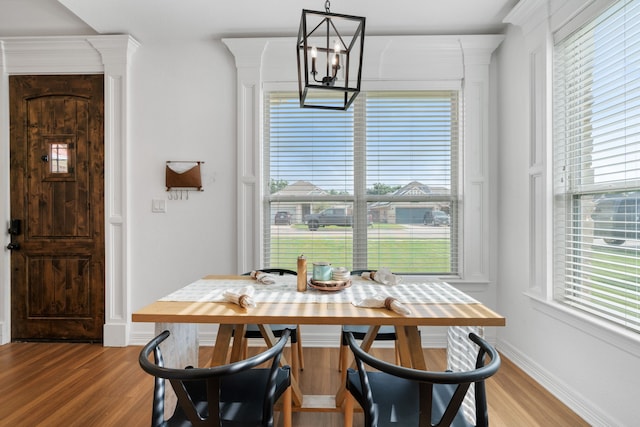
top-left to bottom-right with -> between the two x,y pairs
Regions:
138,330 -> 291,427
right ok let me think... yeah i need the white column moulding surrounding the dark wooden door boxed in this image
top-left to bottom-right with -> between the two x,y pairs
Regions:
0,35 -> 139,346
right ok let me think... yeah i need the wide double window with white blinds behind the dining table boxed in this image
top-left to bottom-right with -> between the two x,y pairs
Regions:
263,91 -> 461,276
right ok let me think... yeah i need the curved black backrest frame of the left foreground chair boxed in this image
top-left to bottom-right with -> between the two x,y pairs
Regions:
138,329 -> 291,426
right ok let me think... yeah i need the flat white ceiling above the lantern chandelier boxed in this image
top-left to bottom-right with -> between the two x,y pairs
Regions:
58,0 -> 518,42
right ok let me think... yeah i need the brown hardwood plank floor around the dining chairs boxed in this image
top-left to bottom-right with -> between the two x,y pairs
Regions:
0,343 -> 588,427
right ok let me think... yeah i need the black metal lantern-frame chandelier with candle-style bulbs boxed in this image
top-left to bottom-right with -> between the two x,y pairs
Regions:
297,0 -> 365,110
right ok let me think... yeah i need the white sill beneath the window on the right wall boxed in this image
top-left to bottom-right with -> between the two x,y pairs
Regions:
525,292 -> 640,356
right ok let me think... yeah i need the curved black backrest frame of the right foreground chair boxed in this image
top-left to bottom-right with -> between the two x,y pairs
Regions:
346,333 -> 500,427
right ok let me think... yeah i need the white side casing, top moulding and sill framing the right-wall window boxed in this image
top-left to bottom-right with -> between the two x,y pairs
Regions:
504,0 -> 640,334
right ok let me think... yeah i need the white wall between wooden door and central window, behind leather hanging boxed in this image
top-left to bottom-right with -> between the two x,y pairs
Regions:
129,37 -> 236,304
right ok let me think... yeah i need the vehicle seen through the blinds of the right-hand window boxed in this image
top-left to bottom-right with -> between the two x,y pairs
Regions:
591,193 -> 640,245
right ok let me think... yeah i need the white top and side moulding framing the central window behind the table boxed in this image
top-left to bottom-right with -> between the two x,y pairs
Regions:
223,35 -> 504,283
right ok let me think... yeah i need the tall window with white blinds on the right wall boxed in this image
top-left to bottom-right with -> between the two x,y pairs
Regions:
553,0 -> 640,332
